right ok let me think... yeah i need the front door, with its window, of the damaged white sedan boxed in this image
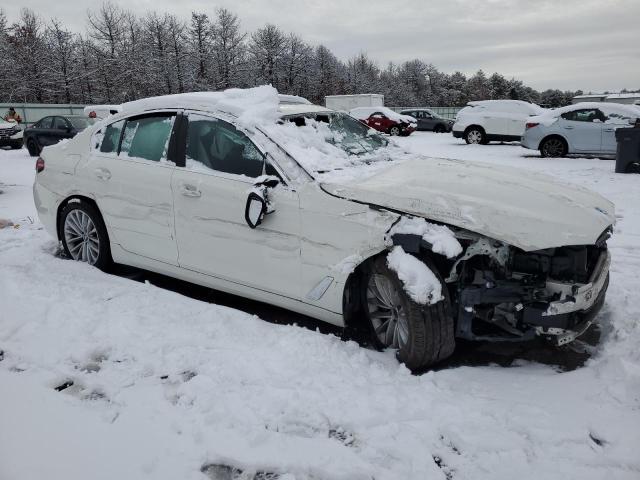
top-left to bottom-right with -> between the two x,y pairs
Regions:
172,113 -> 300,298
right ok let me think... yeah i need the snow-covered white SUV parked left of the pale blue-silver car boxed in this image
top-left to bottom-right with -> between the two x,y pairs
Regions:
453,100 -> 546,144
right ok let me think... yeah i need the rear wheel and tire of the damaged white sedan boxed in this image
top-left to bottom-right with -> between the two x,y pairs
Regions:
60,201 -> 112,270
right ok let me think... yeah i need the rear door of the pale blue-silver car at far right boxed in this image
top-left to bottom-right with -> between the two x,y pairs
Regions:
558,108 -> 604,153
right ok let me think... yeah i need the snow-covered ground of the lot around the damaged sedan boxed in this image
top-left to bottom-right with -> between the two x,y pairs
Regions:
0,133 -> 640,480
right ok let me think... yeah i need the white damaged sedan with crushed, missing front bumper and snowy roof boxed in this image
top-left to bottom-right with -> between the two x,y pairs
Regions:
34,87 -> 614,370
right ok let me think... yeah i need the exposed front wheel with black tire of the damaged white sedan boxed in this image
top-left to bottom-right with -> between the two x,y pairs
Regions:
362,256 -> 455,371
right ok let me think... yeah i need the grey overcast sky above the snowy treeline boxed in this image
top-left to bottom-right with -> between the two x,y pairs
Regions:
3,0 -> 640,91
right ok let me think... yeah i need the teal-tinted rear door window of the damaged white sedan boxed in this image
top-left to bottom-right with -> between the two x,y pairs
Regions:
120,114 -> 175,162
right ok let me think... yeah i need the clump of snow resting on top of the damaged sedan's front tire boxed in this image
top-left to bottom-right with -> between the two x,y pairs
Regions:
387,246 -> 444,305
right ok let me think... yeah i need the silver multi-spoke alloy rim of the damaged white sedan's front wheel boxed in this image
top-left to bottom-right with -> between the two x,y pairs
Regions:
367,274 -> 409,348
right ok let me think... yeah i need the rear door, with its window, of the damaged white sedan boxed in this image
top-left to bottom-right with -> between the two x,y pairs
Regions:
78,112 -> 178,265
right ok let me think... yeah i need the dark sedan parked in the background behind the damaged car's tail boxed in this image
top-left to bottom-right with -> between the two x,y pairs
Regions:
24,115 -> 94,157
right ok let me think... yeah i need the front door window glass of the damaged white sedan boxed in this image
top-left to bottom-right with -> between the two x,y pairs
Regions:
186,115 -> 264,178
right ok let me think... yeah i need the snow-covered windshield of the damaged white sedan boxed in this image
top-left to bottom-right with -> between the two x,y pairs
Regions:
265,112 -> 405,178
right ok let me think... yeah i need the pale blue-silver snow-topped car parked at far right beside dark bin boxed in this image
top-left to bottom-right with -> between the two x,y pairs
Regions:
521,102 -> 640,157
